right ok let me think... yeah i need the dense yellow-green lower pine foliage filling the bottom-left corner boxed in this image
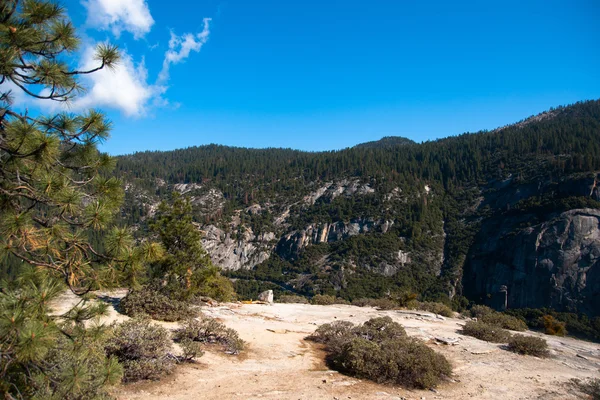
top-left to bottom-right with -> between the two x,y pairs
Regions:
0,276 -> 122,400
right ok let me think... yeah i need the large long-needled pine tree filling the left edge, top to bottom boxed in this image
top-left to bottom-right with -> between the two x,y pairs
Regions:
0,0 -> 161,399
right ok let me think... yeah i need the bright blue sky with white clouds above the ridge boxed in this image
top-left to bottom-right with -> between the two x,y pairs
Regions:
55,0 -> 600,154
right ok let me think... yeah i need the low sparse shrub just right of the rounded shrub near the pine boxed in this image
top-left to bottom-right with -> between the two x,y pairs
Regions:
174,317 -> 245,354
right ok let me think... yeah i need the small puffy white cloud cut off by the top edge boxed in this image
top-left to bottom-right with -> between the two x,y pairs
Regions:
82,0 -> 154,39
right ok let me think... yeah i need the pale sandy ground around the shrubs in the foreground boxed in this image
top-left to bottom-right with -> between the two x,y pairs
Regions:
54,292 -> 600,400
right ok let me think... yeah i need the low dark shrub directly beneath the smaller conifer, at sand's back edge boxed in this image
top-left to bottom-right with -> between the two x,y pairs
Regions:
119,286 -> 198,322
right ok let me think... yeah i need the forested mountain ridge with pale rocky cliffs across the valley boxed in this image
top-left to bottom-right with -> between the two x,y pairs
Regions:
116,100 -> 600,314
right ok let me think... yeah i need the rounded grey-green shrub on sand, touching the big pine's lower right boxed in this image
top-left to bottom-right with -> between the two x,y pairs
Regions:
106,318 -> 175,382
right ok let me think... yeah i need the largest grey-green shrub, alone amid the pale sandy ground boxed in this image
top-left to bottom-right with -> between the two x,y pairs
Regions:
307,317 -> 452,389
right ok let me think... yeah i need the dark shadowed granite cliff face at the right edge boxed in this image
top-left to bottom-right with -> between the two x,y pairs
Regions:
463,209 -> 600,315
